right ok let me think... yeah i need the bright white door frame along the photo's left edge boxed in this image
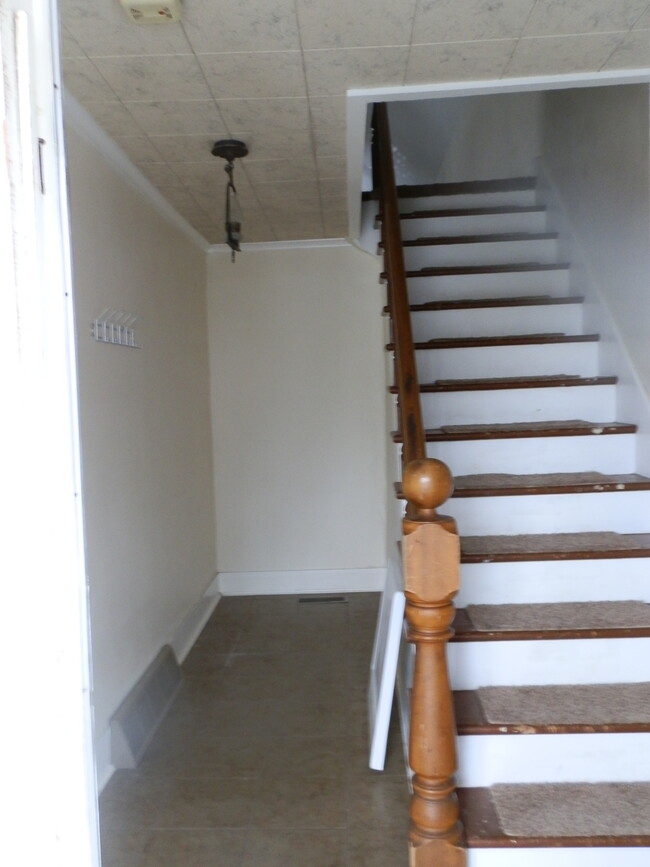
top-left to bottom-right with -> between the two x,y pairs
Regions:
0,0 -> 99,867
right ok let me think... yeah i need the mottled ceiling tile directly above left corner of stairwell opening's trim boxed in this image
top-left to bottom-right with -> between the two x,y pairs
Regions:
304,47 -> 408,96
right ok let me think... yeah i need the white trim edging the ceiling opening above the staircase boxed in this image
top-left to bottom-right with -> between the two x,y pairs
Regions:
346,67 -> 650,244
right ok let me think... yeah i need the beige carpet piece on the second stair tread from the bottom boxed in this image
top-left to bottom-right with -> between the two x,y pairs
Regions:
478,683 -> 650,726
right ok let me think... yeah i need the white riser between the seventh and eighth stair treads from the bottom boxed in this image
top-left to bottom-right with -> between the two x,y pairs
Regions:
415,341 -> 596,380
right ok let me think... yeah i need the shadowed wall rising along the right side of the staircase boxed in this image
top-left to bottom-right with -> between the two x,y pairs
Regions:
544,85 -> 650,394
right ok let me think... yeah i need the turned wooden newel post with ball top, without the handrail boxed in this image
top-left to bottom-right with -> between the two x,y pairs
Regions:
402,458 -> 466,867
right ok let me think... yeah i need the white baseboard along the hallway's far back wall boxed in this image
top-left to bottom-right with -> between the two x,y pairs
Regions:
213,567 -> 386,596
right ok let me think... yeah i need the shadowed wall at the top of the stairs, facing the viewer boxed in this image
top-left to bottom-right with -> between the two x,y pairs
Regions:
390,92 -> 542,184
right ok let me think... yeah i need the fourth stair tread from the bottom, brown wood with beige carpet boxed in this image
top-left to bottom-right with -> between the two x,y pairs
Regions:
461,532 -> 650,563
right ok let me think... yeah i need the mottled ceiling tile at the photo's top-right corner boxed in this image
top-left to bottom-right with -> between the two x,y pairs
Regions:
524,0 -> 648,36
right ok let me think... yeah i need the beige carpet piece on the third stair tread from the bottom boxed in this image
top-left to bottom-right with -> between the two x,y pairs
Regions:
467,602 -> 650,632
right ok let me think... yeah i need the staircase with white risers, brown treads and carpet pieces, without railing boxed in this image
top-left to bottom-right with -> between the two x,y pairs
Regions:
388,178 -> 650,867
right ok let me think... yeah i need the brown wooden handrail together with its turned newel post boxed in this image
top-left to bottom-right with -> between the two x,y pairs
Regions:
373,103 -> 467,867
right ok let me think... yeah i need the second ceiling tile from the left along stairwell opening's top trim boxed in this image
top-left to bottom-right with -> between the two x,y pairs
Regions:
406,39 -> 517,84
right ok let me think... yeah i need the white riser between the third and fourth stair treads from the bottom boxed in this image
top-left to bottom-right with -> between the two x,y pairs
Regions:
456,560 -> 650,608
